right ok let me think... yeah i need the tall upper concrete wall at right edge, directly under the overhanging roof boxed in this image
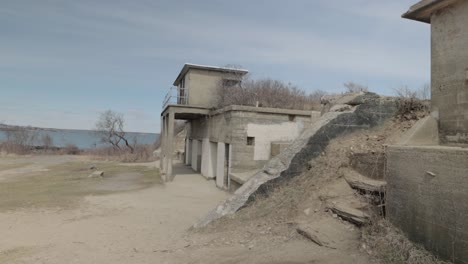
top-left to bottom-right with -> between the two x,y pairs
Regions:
431,1 -> 468,144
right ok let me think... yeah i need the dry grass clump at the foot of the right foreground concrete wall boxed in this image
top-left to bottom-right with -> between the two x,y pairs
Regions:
362,219 -> 449,264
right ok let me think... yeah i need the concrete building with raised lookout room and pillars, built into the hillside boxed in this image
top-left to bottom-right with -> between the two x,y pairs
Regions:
161,64 -> 320,190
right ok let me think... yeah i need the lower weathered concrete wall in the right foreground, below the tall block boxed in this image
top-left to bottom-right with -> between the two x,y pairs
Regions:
386,146 -> 468,263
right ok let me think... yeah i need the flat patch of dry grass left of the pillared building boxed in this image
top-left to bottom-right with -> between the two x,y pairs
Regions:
0,162 -> 162,211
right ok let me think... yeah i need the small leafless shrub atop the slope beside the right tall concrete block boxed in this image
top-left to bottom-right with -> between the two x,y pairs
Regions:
395,85 -> 429,120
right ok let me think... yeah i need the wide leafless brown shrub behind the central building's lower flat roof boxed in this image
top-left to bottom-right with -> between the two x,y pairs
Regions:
218,79 -> 323,110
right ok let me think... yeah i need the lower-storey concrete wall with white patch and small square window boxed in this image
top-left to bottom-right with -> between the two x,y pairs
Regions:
185,107 -> 319,177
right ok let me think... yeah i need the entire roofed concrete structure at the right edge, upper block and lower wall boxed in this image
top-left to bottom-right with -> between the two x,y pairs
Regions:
386,0 -> 468,263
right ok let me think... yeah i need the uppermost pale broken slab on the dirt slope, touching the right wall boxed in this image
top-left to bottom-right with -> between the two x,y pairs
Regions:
339,168 -> 387,193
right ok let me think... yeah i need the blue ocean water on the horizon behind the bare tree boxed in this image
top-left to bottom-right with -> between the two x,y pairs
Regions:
0,129 -> 159,149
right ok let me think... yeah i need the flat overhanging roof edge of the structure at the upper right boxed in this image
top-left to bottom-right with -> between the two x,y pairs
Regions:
402,0 -> 460,23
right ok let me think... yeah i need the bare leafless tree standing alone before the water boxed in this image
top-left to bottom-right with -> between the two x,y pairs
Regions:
96,110 -> 134,153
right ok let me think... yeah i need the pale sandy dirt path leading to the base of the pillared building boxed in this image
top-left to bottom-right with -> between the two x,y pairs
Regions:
0,159 -> 227,264
